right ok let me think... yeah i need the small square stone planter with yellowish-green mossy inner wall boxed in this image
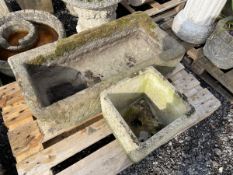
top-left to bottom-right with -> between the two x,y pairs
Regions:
101,67 -> 194,162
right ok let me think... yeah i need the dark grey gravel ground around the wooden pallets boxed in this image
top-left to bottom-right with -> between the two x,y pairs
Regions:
0,0 -> 233,175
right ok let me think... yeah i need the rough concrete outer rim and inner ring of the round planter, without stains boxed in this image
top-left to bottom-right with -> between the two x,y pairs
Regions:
0,10 -> 65,76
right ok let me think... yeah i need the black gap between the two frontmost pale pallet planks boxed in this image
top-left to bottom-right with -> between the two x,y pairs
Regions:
51,134 -> 115,175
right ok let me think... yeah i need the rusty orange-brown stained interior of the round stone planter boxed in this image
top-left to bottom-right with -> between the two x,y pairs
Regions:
0,24 -> 58,60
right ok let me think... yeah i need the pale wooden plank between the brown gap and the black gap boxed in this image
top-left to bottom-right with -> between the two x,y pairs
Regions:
17,119 -> 111,175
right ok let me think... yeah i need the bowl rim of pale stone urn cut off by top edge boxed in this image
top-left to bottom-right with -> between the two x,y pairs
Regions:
63,0 -> 122,10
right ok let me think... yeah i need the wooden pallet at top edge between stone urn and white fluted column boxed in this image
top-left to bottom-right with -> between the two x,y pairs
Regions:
121,0 -> 186,16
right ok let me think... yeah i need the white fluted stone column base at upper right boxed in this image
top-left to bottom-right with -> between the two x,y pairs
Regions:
172,0 -> 227,44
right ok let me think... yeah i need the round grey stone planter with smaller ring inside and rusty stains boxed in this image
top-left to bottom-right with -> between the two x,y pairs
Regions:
0,10 -> 65,76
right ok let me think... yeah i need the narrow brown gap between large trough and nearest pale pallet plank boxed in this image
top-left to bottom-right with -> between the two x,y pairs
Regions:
43,115 -> 103,149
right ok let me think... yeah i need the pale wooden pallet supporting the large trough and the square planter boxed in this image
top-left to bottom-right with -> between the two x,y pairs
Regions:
0,64 -> 220,175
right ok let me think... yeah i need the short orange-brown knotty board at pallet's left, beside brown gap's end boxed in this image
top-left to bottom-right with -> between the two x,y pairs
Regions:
8,121 -> 43,162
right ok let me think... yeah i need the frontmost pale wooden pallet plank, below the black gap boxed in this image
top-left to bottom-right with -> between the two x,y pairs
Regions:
58,141 -> 132,175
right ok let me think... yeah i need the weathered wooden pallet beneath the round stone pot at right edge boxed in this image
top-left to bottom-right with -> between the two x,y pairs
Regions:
186,48 -> 233,103
